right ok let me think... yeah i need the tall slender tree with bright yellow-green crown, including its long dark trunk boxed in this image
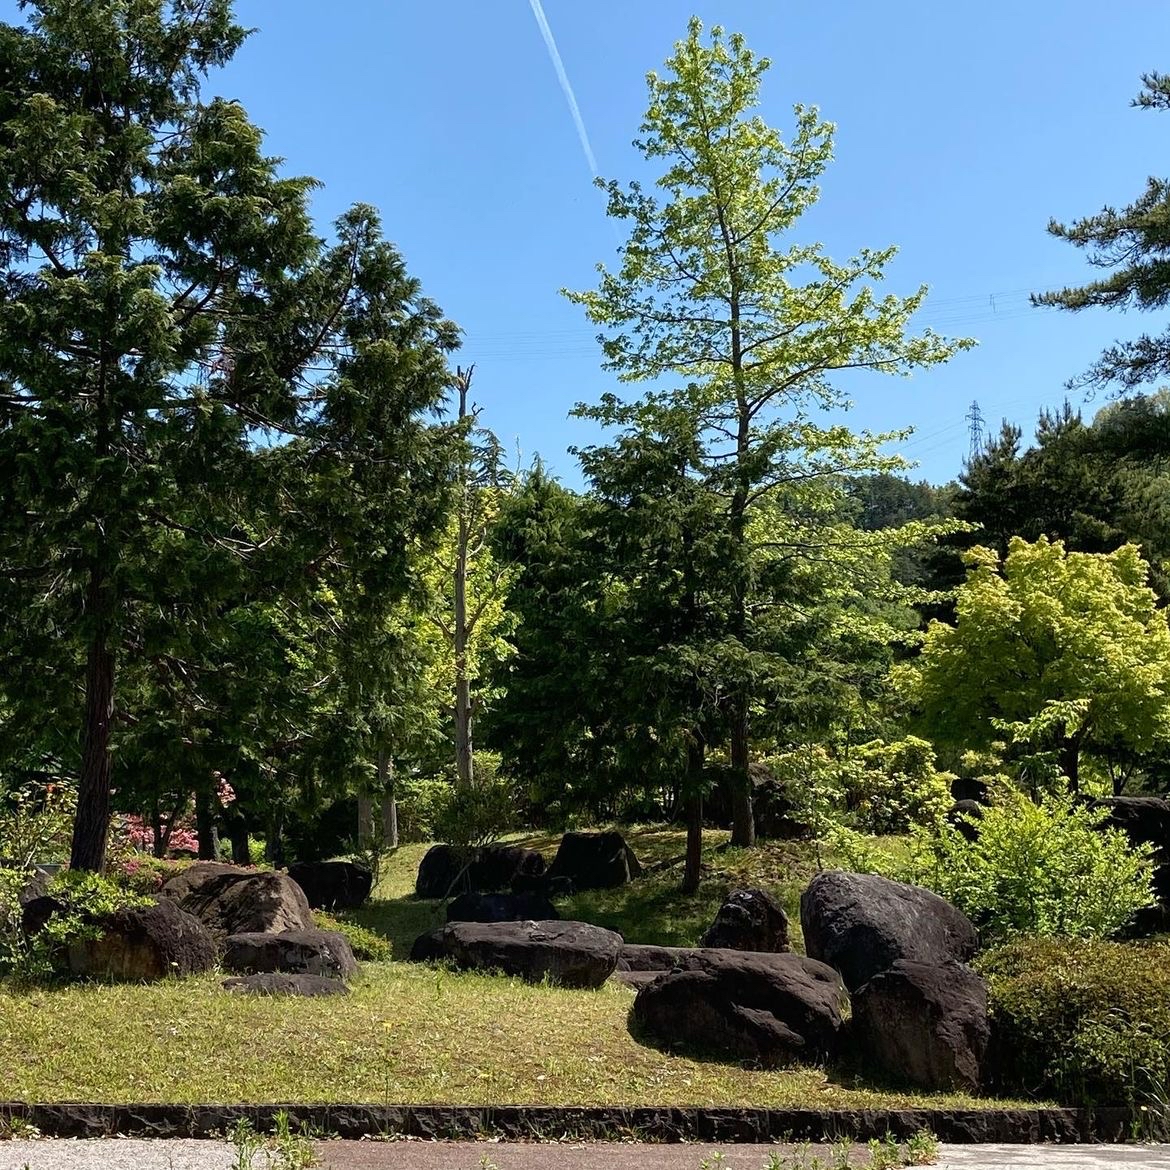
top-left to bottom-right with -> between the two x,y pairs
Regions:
566,19 -> 970,845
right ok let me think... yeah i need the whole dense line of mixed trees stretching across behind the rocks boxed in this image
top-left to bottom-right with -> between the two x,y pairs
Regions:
0,0 -> 1170,886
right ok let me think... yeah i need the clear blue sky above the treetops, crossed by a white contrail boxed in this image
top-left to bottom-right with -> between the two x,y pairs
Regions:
20,0 -> 1170,483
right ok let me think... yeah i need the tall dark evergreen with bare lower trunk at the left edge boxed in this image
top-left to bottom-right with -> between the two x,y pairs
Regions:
0,0 -> 454,869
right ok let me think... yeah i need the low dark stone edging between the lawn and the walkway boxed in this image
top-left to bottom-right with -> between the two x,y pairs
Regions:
0,1102 -> 1137,1144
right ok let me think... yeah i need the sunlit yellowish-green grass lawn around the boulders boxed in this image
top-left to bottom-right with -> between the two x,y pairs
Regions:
0,832 -> 1024,1109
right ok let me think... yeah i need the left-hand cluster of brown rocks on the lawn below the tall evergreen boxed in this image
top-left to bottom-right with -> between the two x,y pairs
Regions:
22,861 -> 370,996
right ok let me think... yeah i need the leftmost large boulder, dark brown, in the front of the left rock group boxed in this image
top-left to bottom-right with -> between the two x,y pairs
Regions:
64,900 -> 215,983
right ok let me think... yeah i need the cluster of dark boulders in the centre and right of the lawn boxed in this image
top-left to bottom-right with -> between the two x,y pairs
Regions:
411,833 -> 990,1092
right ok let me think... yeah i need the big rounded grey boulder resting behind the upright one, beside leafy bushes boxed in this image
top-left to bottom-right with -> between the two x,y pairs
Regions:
800,870 -> 978,991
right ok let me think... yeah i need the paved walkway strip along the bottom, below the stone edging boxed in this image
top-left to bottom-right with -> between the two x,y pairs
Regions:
0,1138 -> 1170,1170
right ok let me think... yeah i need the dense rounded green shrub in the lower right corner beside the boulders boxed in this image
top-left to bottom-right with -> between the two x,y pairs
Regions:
977,938 -> 1170,1106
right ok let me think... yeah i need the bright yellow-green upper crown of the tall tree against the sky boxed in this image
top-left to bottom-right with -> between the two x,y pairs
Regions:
567,20 -> 969,416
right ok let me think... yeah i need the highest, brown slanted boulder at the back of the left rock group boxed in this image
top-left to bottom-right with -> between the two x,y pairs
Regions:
159,861 -> 315,947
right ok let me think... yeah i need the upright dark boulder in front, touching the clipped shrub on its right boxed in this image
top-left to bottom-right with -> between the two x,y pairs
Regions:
849,959 -> 990,1093
